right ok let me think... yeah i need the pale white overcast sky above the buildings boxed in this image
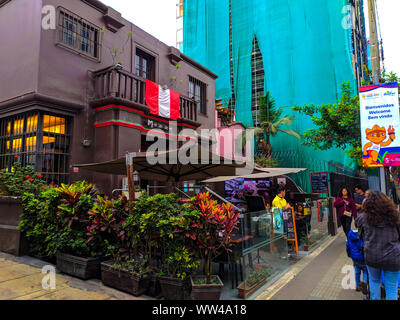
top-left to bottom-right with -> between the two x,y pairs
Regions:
102,0 -> 400,75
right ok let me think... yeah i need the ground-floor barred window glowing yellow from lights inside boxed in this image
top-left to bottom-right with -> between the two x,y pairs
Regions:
0,112 -> 70,184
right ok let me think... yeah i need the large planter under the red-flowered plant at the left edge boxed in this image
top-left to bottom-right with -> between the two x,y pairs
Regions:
0,197 -> 29,256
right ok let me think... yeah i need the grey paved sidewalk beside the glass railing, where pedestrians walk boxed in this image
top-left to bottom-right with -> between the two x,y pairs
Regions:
256,229 -> 364,300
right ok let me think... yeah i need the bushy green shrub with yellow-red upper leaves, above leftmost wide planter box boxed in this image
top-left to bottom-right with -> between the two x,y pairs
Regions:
18,182 -> 102,259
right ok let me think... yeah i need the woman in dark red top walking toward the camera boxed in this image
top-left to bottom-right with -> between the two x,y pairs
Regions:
333,188 -> 357,237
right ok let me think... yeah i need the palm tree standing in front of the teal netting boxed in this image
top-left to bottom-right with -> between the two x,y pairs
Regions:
253,91 -> 301,159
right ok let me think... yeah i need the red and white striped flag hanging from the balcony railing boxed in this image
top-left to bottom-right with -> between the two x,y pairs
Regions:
145,80 -> 181,120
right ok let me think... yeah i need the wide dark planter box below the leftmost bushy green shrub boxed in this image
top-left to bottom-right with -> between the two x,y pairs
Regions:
57,252 -> 101,280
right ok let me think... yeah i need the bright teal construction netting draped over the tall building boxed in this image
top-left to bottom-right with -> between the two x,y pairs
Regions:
183,0 -> 356,191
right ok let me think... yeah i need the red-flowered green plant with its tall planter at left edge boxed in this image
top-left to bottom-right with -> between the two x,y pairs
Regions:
0,161 -> 46,256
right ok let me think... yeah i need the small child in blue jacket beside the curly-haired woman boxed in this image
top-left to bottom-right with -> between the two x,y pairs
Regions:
346,230 -> 368,295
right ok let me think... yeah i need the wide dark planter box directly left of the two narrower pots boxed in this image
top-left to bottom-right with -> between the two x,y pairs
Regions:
101,261 -> 149,296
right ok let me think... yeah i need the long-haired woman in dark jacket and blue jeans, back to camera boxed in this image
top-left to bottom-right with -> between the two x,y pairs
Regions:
356,191 -> 400,300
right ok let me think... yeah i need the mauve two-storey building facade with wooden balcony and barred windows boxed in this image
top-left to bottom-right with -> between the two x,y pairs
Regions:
0,0 -> 217,193
